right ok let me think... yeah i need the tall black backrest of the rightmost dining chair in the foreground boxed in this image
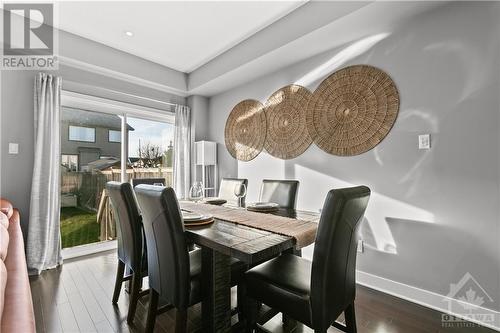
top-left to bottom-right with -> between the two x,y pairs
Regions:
311,186 -> 370,331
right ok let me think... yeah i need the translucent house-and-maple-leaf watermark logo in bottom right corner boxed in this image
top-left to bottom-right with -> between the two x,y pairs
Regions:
441,273 -> 496,328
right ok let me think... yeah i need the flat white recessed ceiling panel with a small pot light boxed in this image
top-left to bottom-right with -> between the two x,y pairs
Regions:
57,1 -> 305,73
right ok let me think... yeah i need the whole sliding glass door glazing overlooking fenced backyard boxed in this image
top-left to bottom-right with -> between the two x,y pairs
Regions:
61,102 -> 174,248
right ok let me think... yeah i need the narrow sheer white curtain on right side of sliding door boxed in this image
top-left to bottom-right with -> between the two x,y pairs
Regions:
174,105 -> 193,198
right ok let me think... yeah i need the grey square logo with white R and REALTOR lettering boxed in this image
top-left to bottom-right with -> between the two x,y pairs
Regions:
2,3 -> 57,70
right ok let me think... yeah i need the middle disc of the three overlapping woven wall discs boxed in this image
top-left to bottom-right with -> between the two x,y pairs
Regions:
264,85 -> 312,159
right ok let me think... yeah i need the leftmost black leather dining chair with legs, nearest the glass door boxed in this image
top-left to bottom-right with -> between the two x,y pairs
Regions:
106,182 -> 147,323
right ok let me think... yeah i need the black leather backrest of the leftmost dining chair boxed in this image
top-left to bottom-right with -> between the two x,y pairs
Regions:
106,182 -> 144,272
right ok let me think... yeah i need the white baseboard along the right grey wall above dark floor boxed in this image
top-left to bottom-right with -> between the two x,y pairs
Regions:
356,271 -> 500,332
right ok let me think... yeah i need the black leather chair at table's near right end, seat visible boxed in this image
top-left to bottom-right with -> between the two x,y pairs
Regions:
241,186 -> 370,333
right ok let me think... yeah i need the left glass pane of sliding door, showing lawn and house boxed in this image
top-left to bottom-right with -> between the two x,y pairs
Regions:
61,107 -> 121,248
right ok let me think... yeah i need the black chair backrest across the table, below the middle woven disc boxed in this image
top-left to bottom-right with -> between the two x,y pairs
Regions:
259,179 -> 299,209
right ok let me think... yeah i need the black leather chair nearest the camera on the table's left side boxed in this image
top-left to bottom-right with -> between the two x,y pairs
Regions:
135,185 -> 244,333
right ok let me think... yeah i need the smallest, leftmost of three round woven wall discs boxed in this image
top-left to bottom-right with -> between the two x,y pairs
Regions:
224,99 -> 266,161
